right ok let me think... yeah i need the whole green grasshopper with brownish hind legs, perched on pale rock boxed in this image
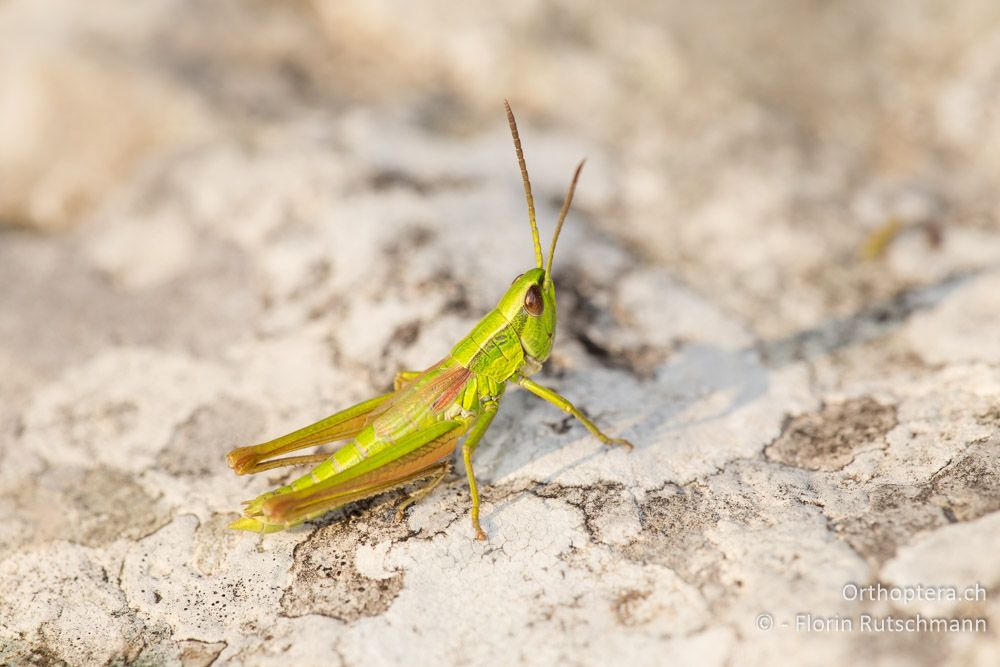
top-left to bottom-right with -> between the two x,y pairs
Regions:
227,101 -> 632,540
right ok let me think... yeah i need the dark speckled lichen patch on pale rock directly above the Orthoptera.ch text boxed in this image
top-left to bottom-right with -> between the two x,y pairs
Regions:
832,485 -> 948,566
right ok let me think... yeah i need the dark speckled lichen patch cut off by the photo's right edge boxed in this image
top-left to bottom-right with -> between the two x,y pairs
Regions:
929,437 -> 1000,521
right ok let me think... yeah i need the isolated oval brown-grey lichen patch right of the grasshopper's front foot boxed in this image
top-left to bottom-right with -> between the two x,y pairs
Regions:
764,397 -> 898,471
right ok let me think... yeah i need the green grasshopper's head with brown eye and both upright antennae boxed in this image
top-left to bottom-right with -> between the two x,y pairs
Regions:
497,100 -> 583,375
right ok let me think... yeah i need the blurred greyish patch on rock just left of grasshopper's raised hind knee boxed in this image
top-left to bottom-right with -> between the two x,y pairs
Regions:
156,396 -> 265,476
